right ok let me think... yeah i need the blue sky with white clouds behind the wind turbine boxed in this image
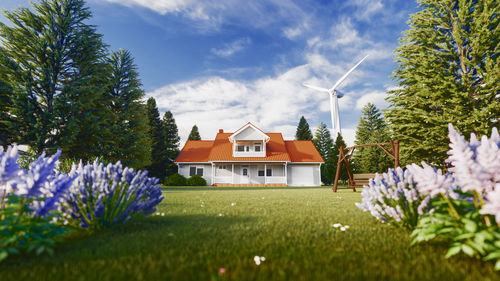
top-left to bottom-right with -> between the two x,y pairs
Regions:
0,0 -> 417,144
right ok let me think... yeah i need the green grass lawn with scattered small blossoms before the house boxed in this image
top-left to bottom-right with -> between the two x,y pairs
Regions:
0,187 -> 500,281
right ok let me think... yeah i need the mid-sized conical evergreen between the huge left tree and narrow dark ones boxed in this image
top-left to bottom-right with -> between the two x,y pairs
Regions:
107,49 -> 151,168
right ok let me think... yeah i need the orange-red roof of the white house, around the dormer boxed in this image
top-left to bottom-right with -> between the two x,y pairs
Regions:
175,126 -> 324,163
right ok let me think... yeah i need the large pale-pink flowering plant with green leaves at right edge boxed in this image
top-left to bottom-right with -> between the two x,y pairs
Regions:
409,124 -> 500,270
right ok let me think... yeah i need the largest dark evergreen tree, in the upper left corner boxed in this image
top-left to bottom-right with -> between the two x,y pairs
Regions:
0,0 -> 113,160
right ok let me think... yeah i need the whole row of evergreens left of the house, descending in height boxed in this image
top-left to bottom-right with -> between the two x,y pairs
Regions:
0,0 -> 189,179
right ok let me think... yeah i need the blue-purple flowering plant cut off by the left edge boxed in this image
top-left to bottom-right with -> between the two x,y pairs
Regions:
0,147 -> 74,261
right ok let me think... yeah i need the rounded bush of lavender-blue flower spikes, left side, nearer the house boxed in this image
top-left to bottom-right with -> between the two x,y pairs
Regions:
60,160 -> 163,229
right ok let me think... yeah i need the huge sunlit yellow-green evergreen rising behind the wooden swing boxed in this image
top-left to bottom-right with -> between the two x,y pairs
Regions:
386,0 -> 500,166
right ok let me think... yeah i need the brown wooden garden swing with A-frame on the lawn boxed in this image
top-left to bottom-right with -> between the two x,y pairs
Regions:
333,140 -> 399,192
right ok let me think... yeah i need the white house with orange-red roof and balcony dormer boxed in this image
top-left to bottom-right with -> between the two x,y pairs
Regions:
175,122 -> 324,186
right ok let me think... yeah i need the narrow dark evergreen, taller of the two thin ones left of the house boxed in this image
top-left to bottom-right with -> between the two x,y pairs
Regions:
147,97 -> 166,178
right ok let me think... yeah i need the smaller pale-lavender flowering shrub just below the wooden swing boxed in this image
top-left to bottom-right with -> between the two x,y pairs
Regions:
356,167 -> 428,229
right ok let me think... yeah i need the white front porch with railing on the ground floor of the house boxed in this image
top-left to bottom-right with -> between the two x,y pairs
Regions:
212,162 -> 287,187
